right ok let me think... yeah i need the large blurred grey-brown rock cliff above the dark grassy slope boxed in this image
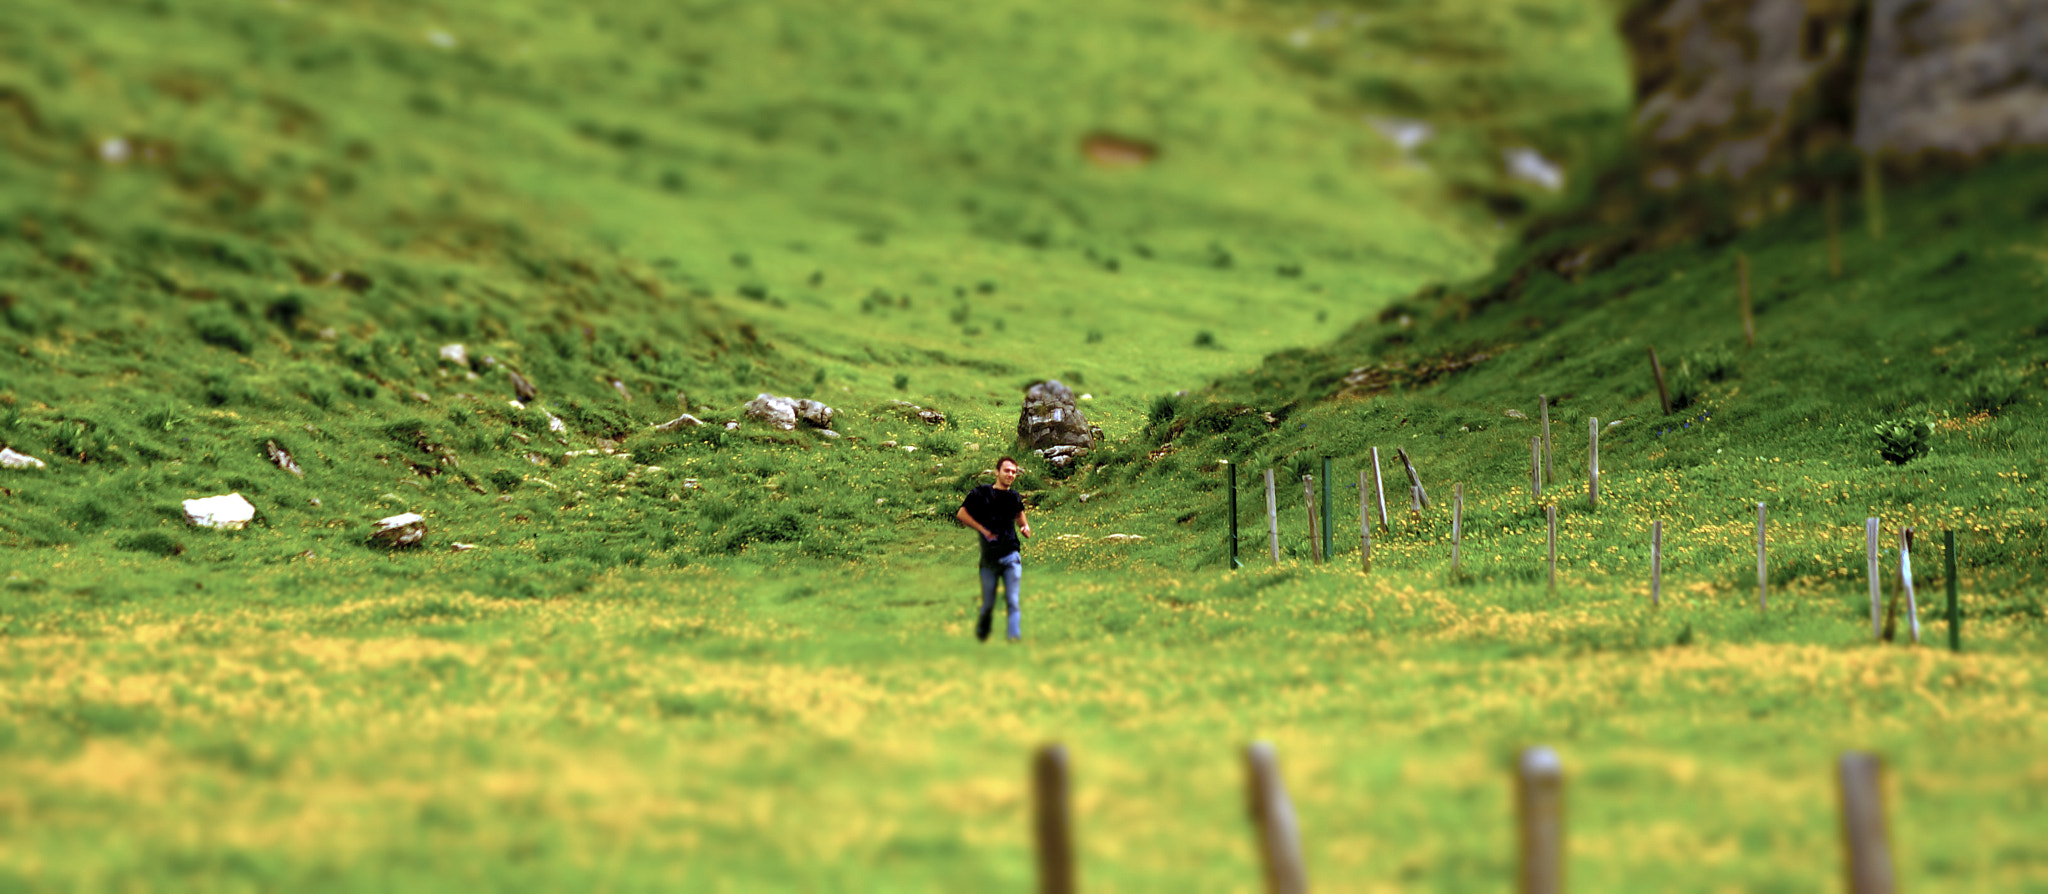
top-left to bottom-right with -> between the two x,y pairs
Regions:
1622,0 -> 2048,203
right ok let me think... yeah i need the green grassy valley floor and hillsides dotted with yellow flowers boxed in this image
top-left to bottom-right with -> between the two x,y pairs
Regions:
0,0 -> 2048,890
